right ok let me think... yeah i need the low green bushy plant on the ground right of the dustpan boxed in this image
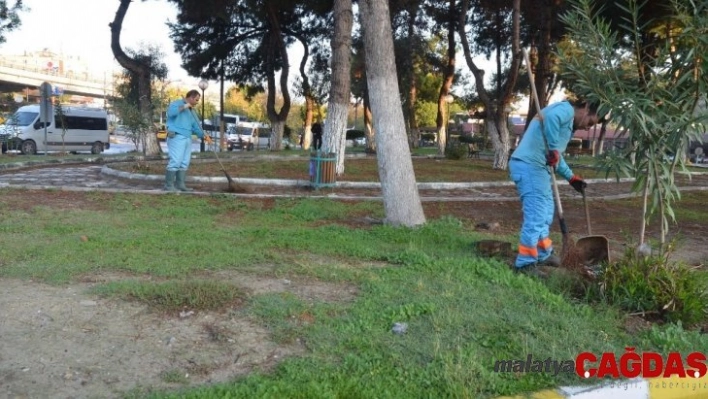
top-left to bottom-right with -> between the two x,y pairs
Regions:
588,249 -> 708,325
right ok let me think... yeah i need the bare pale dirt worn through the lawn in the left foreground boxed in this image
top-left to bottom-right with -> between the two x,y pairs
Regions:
0,274 -> 354,399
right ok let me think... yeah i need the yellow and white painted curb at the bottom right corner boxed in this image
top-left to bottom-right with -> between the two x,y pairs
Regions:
497,375 -> 708,399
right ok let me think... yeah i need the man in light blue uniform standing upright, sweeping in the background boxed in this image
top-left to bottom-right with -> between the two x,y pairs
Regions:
165,90 -> 212,191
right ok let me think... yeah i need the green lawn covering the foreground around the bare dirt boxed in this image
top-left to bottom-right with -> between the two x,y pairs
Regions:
0,191 -> 708,398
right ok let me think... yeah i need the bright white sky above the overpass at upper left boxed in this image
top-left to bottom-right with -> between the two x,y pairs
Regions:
0,0 -> 194,86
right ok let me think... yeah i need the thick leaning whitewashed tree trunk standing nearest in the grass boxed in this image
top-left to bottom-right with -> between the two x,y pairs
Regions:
359,0 -> 425,226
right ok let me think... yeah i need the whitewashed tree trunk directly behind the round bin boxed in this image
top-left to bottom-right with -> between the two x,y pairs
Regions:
322,0 -> 354,176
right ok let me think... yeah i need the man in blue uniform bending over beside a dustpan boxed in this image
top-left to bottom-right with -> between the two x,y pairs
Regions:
509,101 -> 598,272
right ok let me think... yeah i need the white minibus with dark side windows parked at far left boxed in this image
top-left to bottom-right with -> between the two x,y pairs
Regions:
0,104 -> 111,155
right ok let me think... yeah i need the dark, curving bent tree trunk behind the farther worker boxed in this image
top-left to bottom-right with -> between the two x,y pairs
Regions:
108,0 -> 162,156
